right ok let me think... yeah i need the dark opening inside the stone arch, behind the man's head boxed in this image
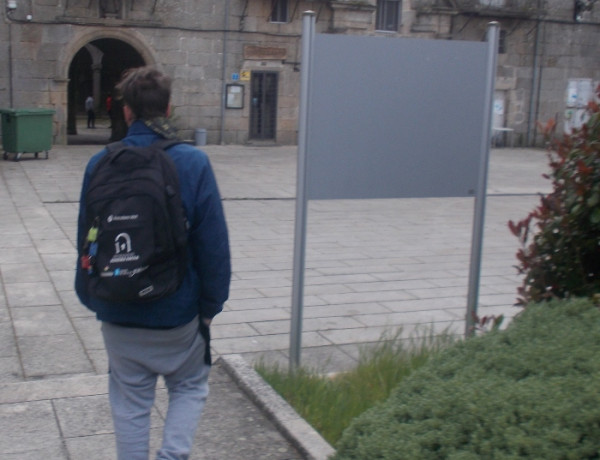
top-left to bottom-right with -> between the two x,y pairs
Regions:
67,38 -> 146,144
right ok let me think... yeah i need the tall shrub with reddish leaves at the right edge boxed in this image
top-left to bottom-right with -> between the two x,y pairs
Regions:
509,90 -> 600,304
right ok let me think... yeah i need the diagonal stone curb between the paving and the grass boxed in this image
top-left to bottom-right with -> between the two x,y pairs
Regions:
219,354 -> 335,460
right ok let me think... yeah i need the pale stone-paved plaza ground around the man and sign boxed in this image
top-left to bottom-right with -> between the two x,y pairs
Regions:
0,127 -> 550,460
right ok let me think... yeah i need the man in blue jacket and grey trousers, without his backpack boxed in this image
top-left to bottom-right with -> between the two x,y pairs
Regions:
75,67 -> 231,460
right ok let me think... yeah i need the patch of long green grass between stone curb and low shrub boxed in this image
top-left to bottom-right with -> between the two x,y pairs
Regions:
256,330 -> 454,444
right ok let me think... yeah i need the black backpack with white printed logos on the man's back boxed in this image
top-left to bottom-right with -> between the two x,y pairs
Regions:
79,140 -> 187,302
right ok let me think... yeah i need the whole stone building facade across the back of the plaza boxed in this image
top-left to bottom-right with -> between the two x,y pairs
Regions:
0,0 -> 600,145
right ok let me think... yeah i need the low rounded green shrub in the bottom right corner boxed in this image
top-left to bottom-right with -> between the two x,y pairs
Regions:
333,299 -> 600,460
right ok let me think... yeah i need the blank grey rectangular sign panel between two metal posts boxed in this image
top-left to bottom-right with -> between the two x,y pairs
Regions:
306,34 -> 488,199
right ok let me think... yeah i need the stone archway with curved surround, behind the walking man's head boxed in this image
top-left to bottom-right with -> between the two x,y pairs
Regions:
54,29 -> 160,144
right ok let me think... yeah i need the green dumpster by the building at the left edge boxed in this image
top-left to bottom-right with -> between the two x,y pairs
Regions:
0,108 -> 54,161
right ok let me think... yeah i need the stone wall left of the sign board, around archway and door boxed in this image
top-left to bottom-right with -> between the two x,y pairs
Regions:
0,0 -> 310,144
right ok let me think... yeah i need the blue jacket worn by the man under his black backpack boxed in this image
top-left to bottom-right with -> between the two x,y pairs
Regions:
75,121 -> 231,328
